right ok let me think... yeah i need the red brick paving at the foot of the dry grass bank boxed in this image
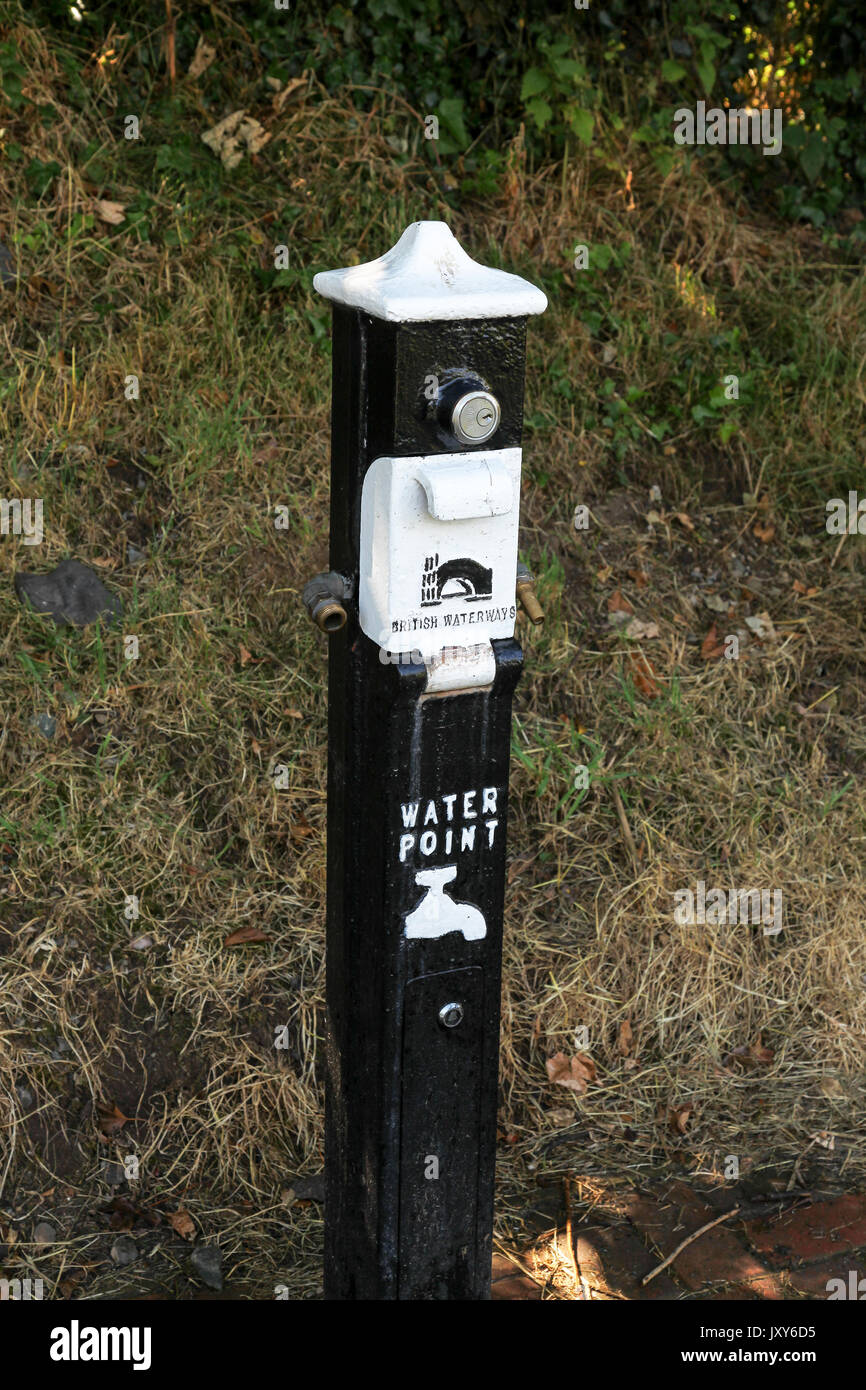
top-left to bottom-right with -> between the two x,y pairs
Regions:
492,1180 -> 866,1301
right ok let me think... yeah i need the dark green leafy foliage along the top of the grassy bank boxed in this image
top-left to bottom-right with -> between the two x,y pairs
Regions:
25,0 -> 866,225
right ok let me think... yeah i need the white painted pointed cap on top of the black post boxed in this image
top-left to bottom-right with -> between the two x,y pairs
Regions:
313,222 -> 548,324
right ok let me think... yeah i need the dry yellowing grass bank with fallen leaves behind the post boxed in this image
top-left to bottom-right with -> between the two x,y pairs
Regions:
0,5 -> 866,1298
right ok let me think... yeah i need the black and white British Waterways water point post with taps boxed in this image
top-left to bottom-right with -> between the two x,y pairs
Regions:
304,222 -> 546,1300
